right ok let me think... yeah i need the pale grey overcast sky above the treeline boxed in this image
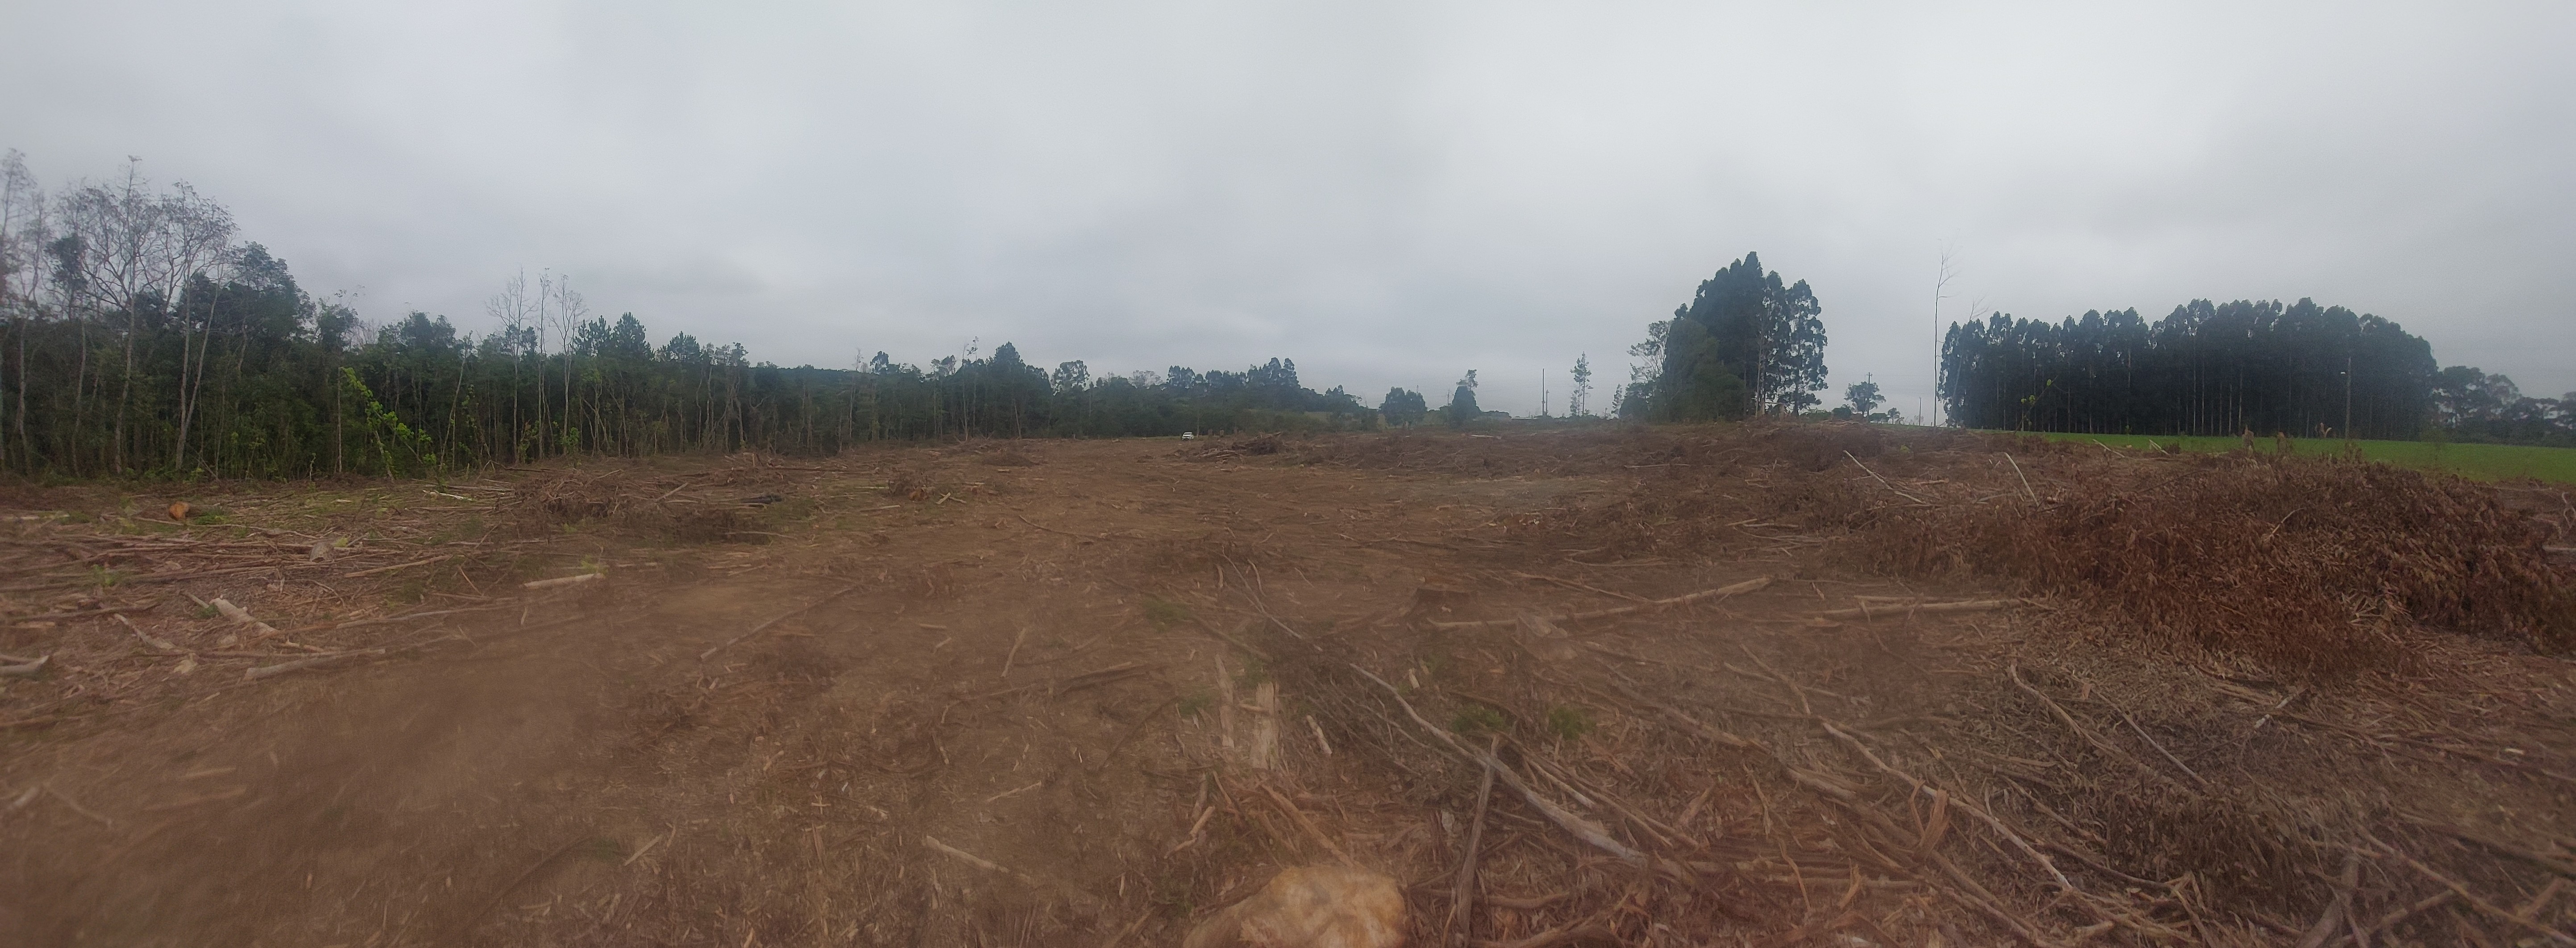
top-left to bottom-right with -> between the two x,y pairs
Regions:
0,0 -> 2576,415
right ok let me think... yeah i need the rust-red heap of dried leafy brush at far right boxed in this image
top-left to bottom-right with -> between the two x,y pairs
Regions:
1842,446 -> 2576,675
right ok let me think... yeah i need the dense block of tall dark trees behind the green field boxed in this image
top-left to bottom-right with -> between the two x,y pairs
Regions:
1940,299 -> 2576,443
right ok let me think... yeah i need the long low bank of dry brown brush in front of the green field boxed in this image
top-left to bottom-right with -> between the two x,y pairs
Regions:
1520,425 -> 2576,675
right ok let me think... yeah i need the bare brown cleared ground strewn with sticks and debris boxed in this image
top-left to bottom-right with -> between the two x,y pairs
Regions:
0,430 -> 2576,948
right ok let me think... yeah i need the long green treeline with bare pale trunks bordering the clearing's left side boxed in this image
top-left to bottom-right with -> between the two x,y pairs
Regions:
0,152 -> 1419,477
